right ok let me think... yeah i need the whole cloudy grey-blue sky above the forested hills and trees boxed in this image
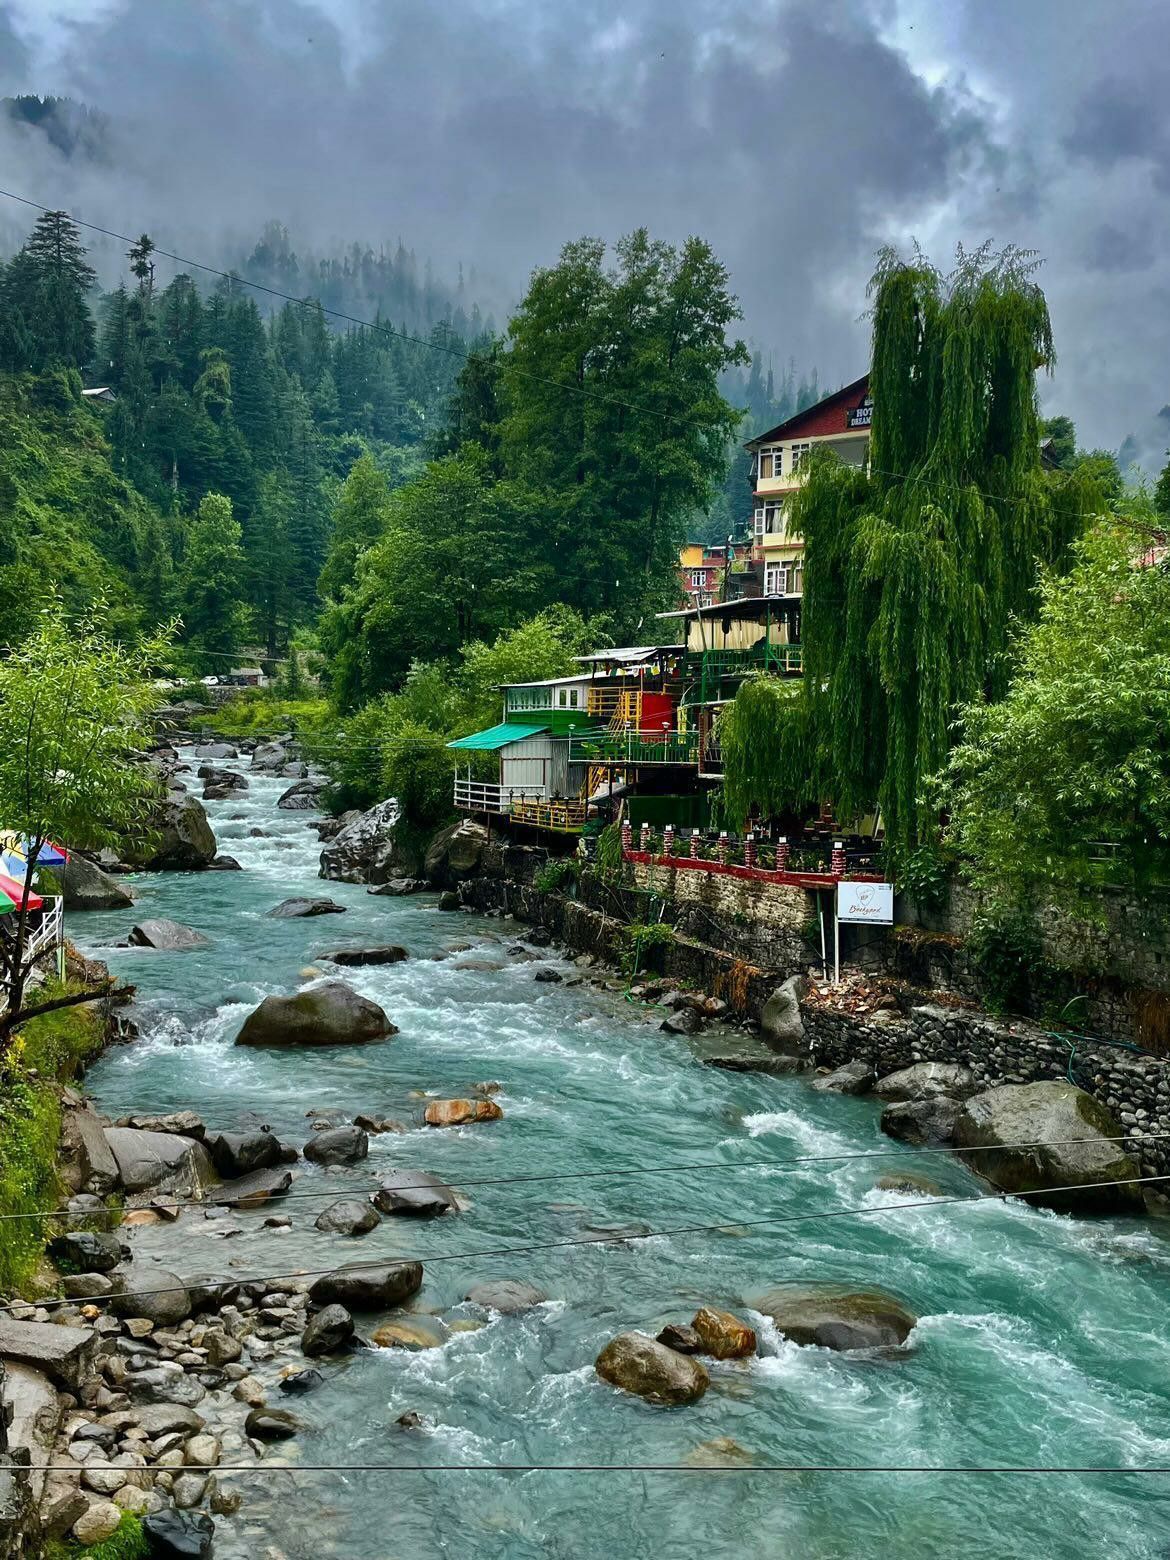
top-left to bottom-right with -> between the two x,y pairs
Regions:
0,0 -> 1170,468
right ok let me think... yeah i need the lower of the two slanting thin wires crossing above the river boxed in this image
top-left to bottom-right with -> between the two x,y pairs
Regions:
15,1175 -> 1170,1312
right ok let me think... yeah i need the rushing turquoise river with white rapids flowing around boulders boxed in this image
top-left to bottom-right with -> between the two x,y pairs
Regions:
70,748 -> 1170,1560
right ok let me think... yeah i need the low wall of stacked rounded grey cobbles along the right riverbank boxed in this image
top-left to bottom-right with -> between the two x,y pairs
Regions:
800,1000 -> 1170,1175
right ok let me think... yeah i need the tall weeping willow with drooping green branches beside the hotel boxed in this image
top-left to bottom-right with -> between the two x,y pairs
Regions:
724,246 -> 1090,846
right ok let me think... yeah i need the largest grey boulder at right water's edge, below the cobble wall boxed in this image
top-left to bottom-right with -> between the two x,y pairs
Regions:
955,1078 -> 1143,1214
